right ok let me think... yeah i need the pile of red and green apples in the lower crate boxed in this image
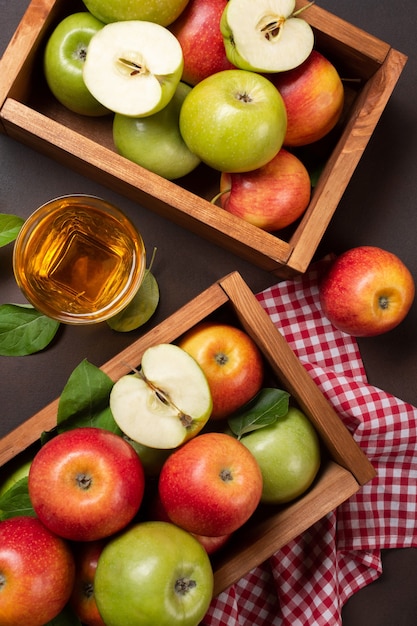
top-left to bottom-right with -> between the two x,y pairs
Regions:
0,322 -> 321,626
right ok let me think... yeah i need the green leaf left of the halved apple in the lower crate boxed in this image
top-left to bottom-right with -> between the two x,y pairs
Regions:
57,359 -> 121,433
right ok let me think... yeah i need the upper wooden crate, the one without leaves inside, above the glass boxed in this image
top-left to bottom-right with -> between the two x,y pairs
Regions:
0,0 -> 406,277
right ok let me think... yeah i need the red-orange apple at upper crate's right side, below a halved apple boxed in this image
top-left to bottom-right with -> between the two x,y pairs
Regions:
270,50 -> 344,146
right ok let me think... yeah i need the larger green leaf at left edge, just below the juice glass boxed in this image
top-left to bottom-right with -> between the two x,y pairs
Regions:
0,304 -> 60,356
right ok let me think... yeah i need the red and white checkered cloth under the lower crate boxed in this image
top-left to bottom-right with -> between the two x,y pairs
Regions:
202,264 -> 417,626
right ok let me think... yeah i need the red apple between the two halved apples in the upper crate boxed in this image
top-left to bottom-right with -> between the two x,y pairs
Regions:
170,0 -> 234,85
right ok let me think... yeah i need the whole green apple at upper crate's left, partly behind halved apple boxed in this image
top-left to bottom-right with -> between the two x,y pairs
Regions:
43,11 -> 109,116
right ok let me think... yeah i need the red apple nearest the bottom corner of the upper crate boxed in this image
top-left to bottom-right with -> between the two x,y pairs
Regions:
220,148 -> 311,232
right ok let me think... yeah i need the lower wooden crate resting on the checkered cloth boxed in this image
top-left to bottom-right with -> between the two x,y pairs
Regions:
0,272 -> 375,595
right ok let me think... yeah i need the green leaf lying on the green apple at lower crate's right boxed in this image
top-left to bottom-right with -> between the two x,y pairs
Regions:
227,388 -> 290,439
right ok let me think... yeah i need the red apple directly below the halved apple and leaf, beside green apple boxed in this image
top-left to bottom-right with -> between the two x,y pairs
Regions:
158,432 -> 262,537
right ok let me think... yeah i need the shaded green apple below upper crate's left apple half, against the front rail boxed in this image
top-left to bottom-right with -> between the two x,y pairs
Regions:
113,82 -> 200,180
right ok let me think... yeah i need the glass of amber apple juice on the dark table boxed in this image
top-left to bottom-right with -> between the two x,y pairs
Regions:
13,194 -> 146,324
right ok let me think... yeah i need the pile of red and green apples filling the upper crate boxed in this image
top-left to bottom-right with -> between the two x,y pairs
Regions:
44,0 -> 344,232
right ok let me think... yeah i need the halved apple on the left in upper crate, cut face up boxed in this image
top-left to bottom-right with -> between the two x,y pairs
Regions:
83,20 -> 184,117
